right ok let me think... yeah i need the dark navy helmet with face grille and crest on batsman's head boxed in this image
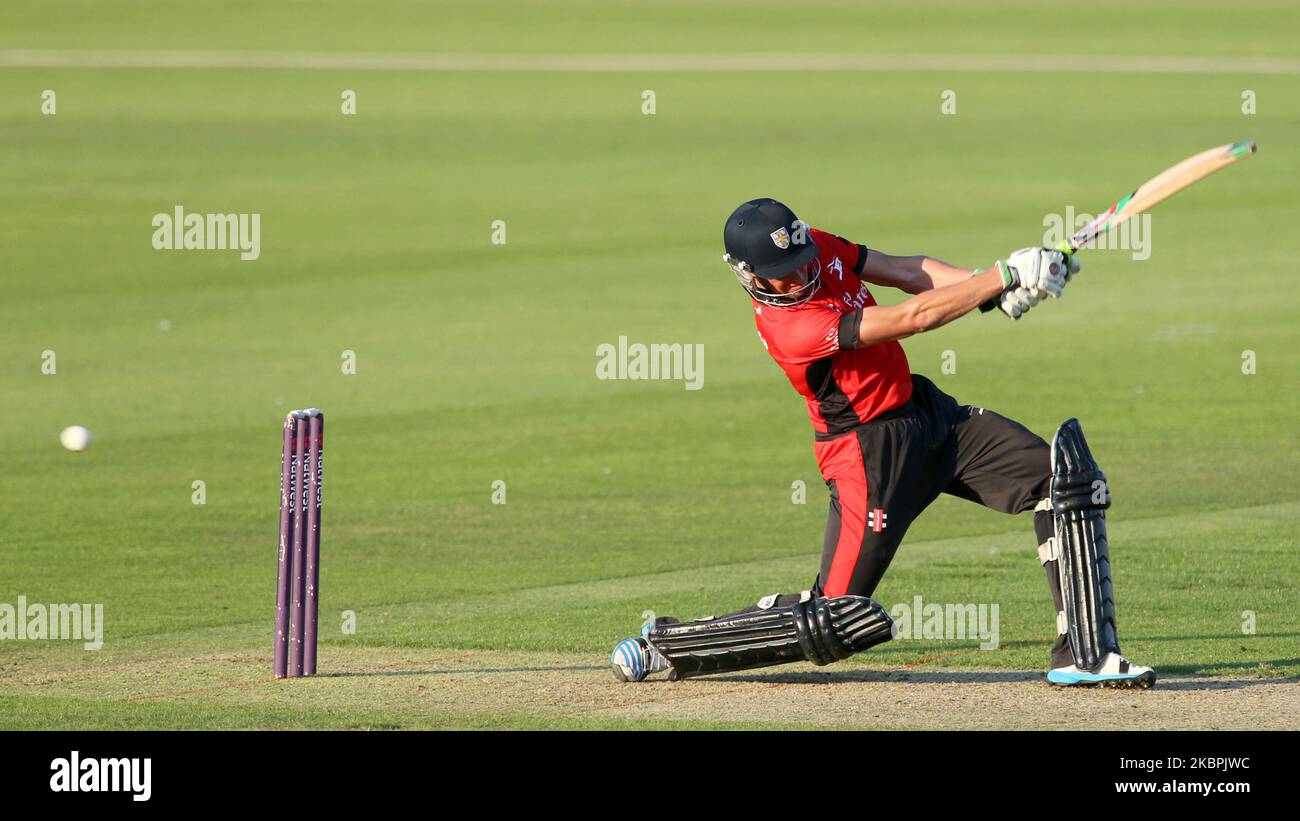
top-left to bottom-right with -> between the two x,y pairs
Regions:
723,197 -> 822,307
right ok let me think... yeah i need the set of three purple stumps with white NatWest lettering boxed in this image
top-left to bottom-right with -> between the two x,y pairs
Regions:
274,408 -> 325,678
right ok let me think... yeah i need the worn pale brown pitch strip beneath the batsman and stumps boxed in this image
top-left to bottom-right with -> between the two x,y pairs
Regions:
0,647 -> 1300,730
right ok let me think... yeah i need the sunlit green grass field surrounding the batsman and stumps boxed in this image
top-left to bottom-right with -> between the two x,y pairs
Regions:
0,0 -> 1300,727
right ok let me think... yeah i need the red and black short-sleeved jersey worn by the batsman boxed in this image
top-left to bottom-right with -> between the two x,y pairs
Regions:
754,229 -> 911,439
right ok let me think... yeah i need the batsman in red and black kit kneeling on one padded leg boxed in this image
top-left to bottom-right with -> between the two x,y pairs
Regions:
611,199 -> 1156,687
